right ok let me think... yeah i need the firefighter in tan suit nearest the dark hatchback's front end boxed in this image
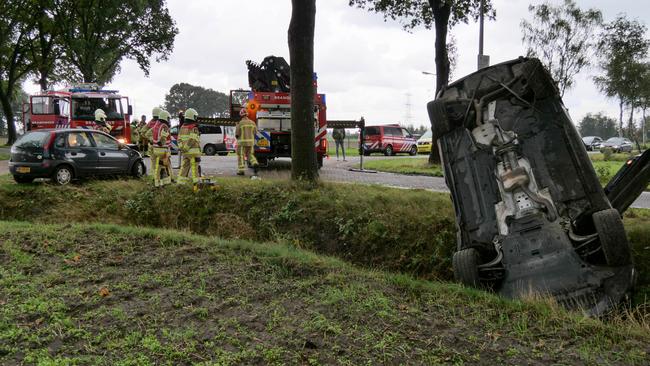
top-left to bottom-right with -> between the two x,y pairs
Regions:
147,110 -> 172,187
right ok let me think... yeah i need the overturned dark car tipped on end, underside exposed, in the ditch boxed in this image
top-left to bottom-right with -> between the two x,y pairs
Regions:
427,58 -> 635,315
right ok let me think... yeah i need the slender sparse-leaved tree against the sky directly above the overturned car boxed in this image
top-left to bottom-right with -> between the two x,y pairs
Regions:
521,0 -> 602,96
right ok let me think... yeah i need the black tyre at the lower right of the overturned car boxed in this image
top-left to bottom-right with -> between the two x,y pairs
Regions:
592,208 -> 632,267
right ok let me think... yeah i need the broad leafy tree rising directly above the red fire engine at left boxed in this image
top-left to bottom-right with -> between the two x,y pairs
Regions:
55,0 -> 178,85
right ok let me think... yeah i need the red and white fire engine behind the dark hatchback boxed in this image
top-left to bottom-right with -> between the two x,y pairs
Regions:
23,84 -> 133,143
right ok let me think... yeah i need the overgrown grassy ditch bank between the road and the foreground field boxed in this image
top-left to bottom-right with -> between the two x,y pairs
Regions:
0,176 -> 650,305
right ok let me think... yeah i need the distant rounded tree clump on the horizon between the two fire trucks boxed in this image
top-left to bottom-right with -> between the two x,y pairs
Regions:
165,83 -> 229,117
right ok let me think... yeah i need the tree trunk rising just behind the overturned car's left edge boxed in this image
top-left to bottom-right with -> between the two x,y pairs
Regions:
429,0 -> 451,164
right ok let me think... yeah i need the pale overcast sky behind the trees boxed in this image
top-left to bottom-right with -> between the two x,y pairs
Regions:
26,0 -> 650,126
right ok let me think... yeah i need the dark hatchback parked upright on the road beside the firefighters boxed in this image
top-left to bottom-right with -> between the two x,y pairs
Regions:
9,128 -> 146,185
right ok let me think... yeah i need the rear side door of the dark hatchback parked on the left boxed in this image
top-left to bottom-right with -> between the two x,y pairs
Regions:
62,130 -> 97,175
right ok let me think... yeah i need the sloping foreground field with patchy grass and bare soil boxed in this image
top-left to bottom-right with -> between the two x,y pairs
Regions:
0,222 -> 650,365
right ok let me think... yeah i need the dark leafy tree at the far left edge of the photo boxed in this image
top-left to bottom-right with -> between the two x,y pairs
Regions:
0,0 -> 35,144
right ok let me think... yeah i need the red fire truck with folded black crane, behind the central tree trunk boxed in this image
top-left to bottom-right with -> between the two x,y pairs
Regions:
198,56 -> 328,167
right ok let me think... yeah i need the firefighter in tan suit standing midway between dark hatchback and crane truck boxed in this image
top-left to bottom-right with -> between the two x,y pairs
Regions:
177,108 -> 201,183
